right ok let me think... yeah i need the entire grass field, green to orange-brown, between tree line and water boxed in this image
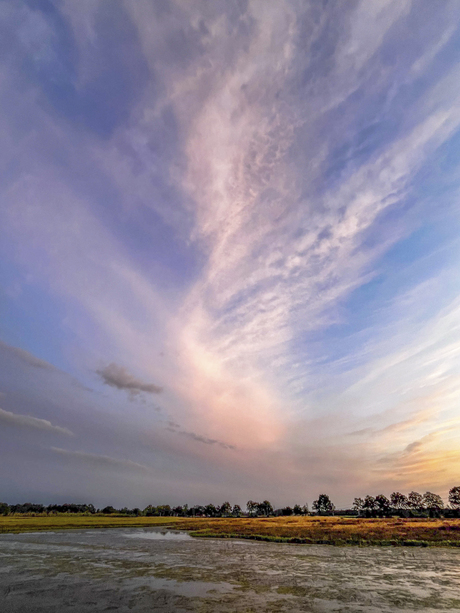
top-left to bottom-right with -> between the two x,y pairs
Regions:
0,514 -> 460,547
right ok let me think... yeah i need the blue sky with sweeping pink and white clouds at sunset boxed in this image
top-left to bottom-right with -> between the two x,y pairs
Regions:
0,0 -> 460,508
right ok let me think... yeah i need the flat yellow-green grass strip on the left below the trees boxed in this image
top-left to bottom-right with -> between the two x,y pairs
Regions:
0,513 -> 178,533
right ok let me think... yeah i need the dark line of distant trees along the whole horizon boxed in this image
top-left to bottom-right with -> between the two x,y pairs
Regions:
0,486 -> 460,517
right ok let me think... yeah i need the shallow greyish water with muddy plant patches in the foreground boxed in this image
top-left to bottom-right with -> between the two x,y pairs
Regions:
0,528 -> 460,613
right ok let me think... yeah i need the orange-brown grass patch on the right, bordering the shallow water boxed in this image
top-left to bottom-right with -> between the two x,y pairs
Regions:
180,517 -> 460,546
